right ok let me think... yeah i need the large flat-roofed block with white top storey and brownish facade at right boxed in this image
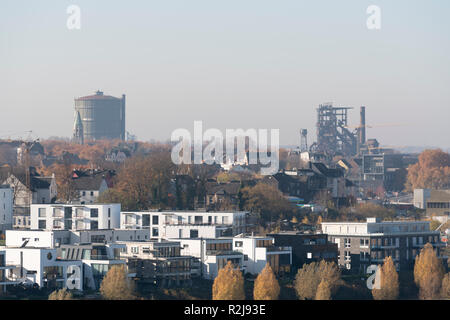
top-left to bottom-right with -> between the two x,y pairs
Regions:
322,218 -> 444,274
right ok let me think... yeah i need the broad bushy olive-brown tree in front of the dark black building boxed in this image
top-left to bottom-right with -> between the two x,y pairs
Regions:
294,260 -> 341,300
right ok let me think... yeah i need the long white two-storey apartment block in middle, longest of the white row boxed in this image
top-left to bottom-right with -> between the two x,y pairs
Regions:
120,211 -> 248,239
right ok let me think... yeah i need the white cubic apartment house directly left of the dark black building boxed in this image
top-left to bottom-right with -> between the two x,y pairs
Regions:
233,235 -> 292,275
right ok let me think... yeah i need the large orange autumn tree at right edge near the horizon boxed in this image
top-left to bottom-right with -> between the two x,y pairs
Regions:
406,149 -> 450,191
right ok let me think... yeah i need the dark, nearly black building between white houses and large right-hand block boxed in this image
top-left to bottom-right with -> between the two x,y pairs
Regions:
267,231 -> 338,271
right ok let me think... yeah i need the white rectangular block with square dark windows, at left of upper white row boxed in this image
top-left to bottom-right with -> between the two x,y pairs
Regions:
30,204 -> 120,230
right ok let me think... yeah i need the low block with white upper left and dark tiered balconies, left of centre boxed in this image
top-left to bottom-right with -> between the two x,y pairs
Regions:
119,240 -> 192,288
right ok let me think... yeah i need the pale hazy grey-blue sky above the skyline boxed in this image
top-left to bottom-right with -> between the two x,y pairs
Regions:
0,0 -> 450,148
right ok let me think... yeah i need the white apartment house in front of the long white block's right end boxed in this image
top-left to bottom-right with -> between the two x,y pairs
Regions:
174,238 -> 244,280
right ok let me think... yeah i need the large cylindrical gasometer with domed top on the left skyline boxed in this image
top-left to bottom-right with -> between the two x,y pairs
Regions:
73,91 -> 125,144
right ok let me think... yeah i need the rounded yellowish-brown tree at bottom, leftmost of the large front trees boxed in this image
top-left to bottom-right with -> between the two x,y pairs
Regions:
100,265 -> 135,300
